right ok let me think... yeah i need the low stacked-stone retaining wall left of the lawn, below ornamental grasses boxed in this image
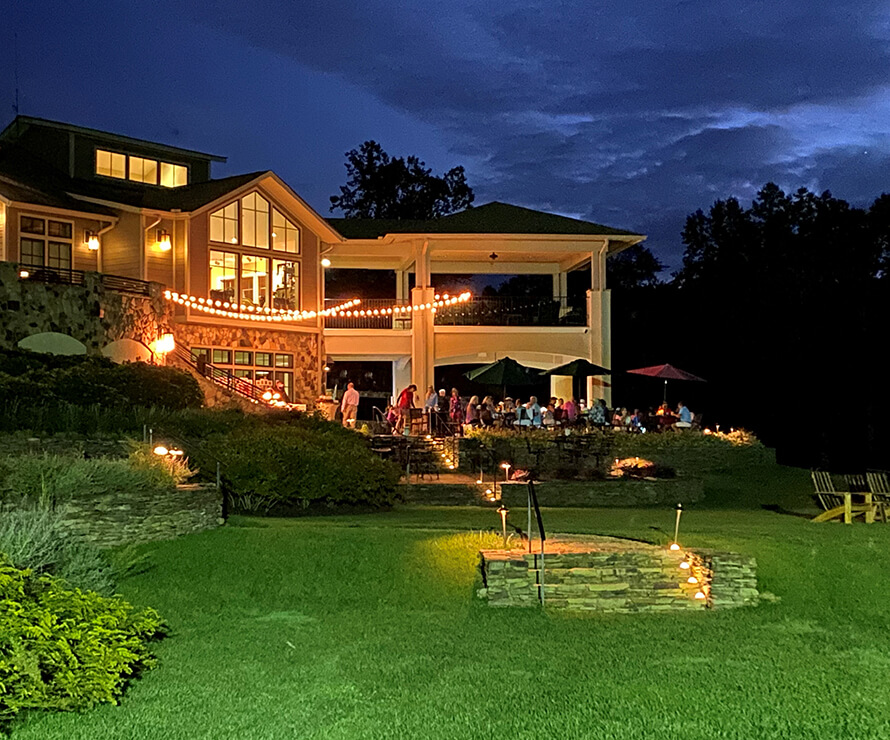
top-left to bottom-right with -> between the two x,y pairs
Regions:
2,484 -> 223,547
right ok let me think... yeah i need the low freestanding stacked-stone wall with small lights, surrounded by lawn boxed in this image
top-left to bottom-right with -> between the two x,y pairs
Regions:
478,538 -> 758,613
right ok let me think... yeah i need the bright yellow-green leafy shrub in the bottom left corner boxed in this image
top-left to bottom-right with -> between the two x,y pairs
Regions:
0,555 -> 164,723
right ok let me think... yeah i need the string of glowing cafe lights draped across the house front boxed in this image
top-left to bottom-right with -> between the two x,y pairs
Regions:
164,290 -> 472,322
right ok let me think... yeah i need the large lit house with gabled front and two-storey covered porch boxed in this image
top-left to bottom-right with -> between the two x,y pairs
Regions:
0,116 -> 644,403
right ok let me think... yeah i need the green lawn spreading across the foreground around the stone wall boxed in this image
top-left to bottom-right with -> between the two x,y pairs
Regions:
13,468 -> 890,740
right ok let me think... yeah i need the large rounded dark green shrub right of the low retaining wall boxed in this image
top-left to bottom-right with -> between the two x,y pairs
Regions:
199,417 -> 400,513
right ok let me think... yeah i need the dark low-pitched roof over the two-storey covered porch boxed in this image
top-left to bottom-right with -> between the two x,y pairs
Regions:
327,201 -> 640,239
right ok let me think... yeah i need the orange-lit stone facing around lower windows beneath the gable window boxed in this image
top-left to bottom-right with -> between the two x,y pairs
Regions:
173,324 -> 322,406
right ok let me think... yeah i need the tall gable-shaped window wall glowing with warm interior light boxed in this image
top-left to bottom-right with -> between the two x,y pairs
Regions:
210,192 -> 300,310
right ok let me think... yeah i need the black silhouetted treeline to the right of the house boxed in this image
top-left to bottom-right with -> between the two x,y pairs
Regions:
610,184 -> 890,469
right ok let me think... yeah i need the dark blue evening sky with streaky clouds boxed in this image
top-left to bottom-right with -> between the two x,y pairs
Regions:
0,0 -> 890,266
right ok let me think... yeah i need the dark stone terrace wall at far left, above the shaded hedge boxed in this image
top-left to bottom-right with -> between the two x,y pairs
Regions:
0,262 -> 171,354
